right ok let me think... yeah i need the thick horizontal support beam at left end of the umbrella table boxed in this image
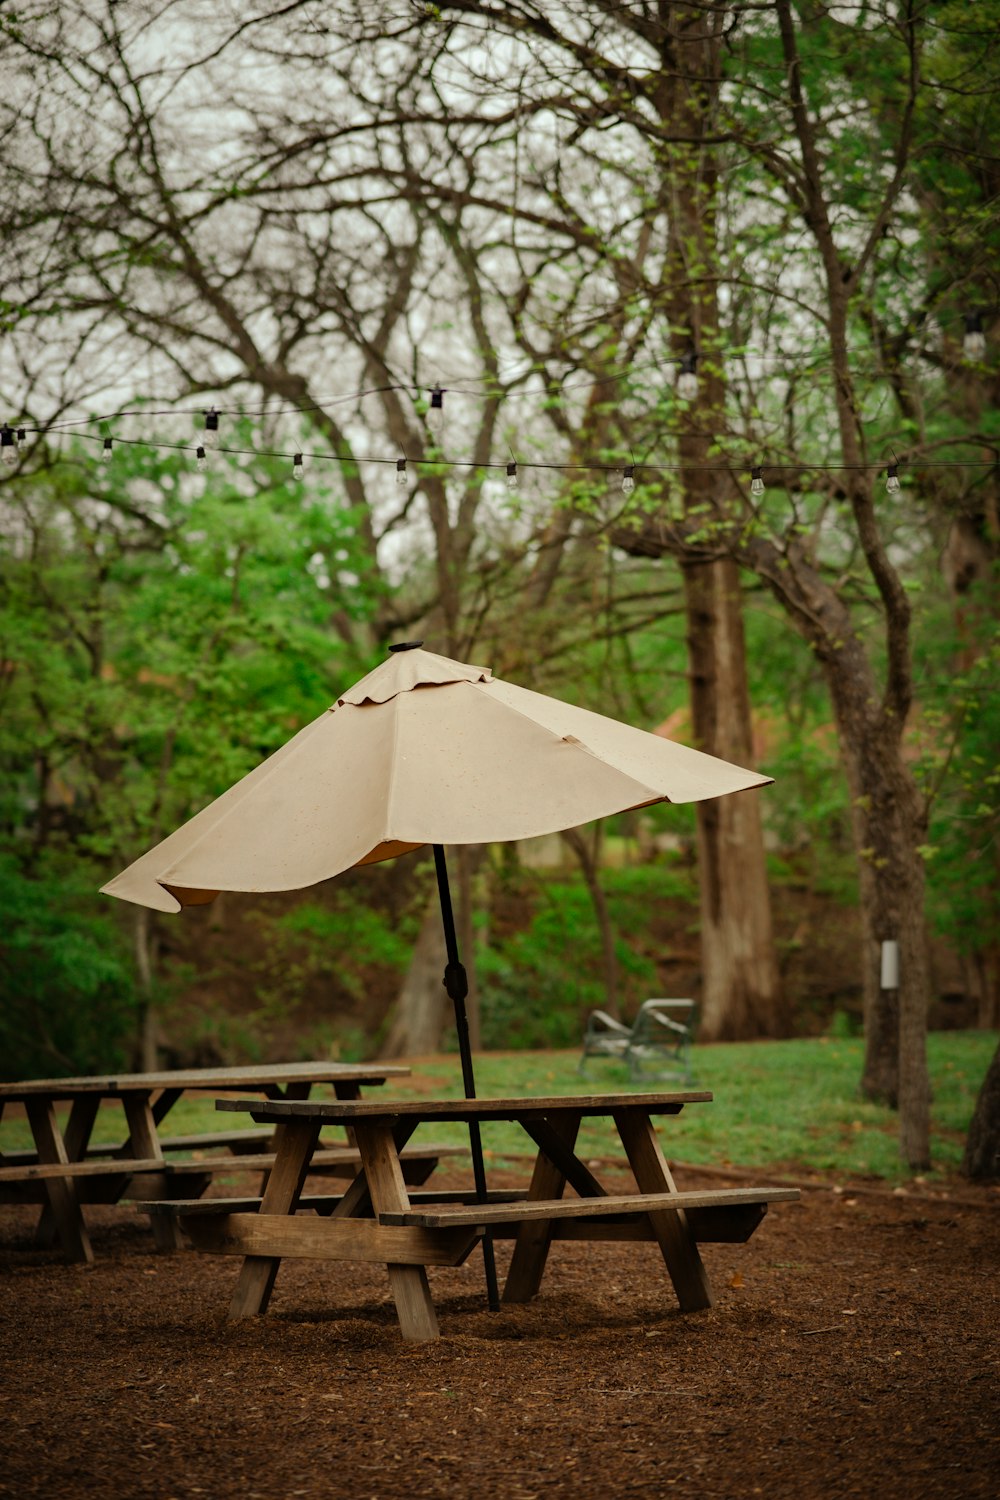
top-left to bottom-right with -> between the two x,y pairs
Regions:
180,1214 -> 478,1266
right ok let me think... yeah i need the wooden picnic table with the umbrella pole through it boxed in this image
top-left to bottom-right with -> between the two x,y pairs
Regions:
159,1092 -> 798,1340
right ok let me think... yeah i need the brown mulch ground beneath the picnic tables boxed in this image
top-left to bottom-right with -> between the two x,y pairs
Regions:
0,1172 -> 1000,1500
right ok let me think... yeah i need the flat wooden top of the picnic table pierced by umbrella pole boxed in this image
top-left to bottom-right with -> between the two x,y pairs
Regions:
216,1091 -> 712,1122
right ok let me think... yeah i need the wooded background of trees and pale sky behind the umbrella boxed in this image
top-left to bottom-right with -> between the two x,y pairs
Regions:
0,0 -> 1000,1167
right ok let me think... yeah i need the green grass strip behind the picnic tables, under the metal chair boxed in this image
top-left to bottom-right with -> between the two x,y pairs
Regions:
0,1032 -> 997,1182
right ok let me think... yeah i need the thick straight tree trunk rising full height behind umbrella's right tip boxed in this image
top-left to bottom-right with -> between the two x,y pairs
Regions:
655,6 -> 787,1040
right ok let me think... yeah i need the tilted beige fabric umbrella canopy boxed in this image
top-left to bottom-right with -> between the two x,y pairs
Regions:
102,648 -> 771,912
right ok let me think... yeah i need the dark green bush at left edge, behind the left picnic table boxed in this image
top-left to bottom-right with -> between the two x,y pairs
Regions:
0,852 -> 136,1079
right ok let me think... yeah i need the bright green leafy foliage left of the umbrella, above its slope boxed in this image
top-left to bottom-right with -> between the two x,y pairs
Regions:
0,425 -> 379,1067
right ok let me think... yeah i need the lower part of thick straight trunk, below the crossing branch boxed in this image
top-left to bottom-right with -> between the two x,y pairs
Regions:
684,560 -> 789,1041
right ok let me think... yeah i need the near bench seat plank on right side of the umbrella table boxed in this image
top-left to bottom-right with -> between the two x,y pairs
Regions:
379,1188 -> 799,1229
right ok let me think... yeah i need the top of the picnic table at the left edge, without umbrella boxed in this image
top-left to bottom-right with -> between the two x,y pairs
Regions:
0,1062 -> 409,1103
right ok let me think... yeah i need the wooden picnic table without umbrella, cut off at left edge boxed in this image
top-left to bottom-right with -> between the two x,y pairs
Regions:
0,1062 -> 409,1263
